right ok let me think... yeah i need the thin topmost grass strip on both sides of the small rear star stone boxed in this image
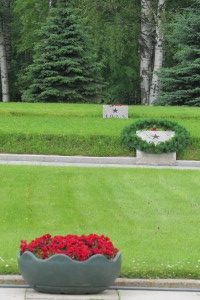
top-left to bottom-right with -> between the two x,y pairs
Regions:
0,102 -> 200,119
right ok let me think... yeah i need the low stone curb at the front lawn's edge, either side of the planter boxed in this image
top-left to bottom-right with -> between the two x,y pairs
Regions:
0,275 -> 200,289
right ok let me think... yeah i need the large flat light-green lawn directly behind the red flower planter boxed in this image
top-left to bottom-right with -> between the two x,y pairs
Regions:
0,166 -> 200,278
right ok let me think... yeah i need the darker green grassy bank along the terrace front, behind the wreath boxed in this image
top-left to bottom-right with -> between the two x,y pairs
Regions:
0,126 -> 197,160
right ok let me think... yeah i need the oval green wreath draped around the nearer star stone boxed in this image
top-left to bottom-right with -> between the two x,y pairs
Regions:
121,119 -> 190,153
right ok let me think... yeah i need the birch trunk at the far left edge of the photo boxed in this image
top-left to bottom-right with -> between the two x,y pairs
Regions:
0,18 -> 10,102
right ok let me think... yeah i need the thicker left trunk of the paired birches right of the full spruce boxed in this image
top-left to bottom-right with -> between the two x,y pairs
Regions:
140,0 -> 153,104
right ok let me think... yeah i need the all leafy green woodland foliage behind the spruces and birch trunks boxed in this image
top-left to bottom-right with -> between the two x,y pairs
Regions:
0,0 -> 199,104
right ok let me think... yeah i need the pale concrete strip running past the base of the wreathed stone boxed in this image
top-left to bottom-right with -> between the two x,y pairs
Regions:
0,154 -> 200,170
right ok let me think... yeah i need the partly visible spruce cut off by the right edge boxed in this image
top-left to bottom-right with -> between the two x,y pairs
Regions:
158,5 -> 200,106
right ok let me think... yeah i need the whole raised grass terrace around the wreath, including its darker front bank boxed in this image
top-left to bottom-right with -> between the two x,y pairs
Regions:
0,103 -> 200,160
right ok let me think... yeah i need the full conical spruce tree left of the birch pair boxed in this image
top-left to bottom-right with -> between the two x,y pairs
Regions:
22,1 -> 102,102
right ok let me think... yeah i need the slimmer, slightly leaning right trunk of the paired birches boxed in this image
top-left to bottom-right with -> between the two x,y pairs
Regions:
149,0 -> 166,105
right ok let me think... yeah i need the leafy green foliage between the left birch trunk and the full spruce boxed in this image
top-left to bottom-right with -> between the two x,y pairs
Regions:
11,0 -> 49,101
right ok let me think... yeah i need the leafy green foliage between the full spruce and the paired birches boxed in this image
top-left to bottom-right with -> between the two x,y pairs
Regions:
74,0 -> 140,103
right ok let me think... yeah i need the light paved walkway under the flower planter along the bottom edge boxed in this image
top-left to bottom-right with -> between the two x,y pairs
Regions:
0,288 -> 200,300
